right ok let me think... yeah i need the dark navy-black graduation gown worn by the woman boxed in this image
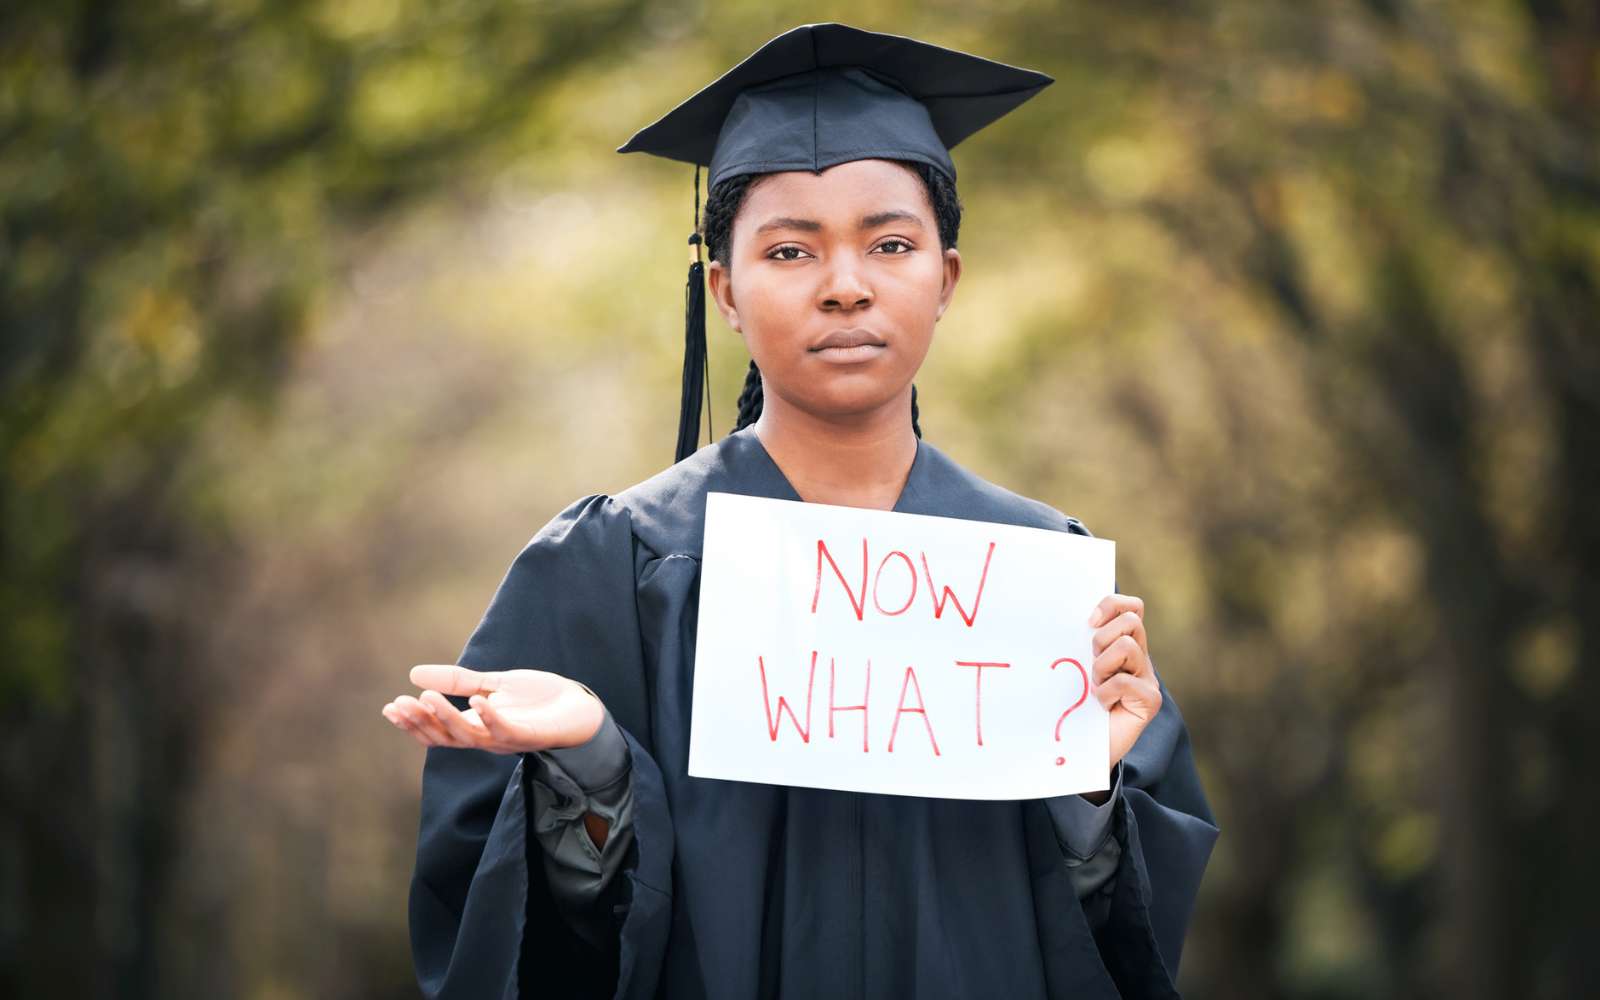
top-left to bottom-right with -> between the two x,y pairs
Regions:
410,427 -> 1218,1000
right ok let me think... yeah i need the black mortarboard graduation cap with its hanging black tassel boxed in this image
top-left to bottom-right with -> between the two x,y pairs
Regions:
618,22 -> 1054,461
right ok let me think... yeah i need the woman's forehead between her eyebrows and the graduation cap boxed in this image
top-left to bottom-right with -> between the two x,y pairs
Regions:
738,160 -> 933,222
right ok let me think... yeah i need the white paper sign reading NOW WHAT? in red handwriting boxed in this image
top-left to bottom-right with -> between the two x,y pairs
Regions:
688,493 -> 1115,798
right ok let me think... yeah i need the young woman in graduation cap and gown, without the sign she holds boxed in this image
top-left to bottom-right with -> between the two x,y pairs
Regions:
384,24 -> 1218,998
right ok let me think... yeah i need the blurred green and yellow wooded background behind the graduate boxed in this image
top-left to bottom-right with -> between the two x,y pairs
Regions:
0,0 -> 1600,1000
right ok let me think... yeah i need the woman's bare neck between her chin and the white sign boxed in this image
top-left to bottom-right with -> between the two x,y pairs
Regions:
754,386 -> 917,510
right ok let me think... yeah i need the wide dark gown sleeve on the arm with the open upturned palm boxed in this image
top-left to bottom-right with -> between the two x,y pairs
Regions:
410,494 -> 672,1000
